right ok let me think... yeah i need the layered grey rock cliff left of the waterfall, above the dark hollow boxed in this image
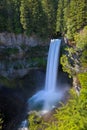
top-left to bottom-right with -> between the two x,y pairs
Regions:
0,32 -> 49,78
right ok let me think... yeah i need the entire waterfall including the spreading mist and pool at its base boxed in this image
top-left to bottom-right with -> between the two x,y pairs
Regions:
28,39 -> 67,113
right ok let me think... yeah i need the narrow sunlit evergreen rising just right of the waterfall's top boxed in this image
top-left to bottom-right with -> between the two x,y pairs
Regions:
56,0 -> 70,33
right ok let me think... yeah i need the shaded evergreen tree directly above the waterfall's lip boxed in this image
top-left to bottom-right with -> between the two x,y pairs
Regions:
42,0 -> 57,37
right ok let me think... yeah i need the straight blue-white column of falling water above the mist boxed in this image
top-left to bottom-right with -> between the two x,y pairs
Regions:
45,39 -> 61,91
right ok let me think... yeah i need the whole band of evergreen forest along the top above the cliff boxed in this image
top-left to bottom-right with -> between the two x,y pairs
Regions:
0,0 -> 87,39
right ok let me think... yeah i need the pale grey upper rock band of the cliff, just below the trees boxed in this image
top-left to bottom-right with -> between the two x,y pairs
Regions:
0,32 -> 47,46
